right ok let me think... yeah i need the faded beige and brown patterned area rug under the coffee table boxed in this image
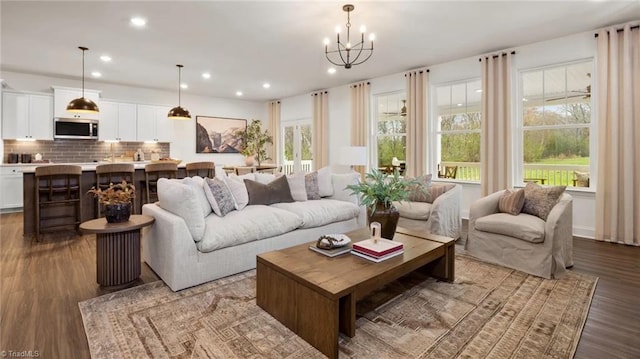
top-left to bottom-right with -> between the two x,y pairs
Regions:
79,255 -> 597,359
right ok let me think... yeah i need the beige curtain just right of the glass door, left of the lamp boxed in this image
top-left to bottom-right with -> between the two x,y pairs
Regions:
311,91 -> 329,169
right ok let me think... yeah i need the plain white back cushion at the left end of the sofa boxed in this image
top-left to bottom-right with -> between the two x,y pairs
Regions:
158,178 -> 205,242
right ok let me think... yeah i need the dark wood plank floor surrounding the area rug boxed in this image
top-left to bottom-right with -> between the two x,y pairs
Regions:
0,213 -> 640,359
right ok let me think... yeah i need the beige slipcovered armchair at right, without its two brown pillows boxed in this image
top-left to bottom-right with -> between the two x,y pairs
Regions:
466,190 -> 573,279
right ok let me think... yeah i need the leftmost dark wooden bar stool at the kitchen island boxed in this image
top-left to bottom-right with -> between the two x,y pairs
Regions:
35,165 -> 82,241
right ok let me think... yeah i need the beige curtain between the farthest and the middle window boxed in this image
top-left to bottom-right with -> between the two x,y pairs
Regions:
405,70 -> 429,177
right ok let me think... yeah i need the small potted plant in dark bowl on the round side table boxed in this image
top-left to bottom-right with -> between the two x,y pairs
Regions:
87,181 -> 136,223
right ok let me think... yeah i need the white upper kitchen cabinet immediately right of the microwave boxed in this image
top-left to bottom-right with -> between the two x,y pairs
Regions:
98,101 -> 137,142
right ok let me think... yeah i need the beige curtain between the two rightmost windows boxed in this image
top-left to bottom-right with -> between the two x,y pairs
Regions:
480,53 -> 513,196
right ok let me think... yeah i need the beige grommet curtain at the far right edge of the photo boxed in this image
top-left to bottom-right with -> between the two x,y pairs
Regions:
596,25 -> 640,246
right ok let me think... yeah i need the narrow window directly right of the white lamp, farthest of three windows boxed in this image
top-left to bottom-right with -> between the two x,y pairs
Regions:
374,92 -> 407,168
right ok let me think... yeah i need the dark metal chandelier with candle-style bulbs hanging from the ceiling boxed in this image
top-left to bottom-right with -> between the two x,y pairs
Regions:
324,4 -> 375,69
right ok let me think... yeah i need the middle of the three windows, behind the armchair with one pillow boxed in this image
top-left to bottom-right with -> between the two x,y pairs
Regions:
433,79 -> 482,182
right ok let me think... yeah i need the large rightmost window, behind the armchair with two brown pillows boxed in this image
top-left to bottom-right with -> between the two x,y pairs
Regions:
518,60 -> 593,187
